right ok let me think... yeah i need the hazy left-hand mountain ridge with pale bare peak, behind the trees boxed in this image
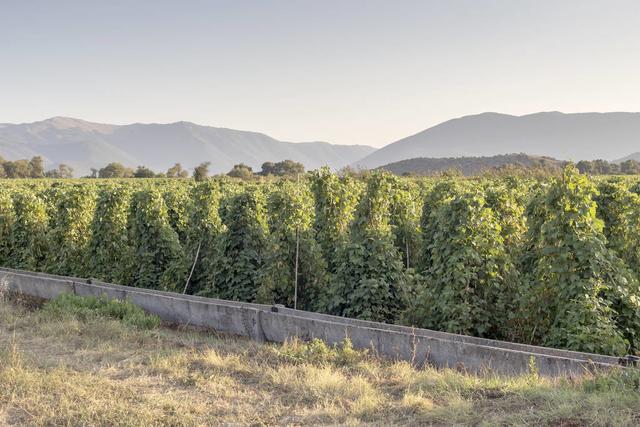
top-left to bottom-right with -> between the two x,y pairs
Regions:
0,117 -> 375,175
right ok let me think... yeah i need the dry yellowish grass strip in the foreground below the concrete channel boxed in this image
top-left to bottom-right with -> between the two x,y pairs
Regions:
0,301 -> 640,426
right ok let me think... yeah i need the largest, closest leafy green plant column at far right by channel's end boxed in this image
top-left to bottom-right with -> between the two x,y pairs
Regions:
521,165 -> 640,355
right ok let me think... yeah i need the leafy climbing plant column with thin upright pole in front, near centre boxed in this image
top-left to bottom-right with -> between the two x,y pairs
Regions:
258,181 -> 327,310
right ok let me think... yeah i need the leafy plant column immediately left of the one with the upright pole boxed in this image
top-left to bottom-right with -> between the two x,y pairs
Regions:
202,187 -> 268,302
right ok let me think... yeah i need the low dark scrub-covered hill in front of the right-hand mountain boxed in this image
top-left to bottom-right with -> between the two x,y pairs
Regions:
378,153 -> 566,176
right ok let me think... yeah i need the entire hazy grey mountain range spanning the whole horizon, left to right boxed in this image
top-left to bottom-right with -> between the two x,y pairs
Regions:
0,112 -> 640,175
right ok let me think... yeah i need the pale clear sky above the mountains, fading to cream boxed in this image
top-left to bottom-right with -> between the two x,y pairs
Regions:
0,0 -> 640,147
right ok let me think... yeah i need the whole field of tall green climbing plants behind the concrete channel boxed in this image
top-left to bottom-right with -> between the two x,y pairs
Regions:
0,166 -> 640,355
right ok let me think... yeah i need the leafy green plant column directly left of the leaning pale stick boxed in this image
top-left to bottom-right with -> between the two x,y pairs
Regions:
128,188 -> 187,292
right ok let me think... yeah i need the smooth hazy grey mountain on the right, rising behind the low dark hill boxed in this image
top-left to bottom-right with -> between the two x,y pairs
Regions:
352,111 -> 640,168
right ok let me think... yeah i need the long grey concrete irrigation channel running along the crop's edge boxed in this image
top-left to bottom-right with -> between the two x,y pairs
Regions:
0,268 -> 627,376
